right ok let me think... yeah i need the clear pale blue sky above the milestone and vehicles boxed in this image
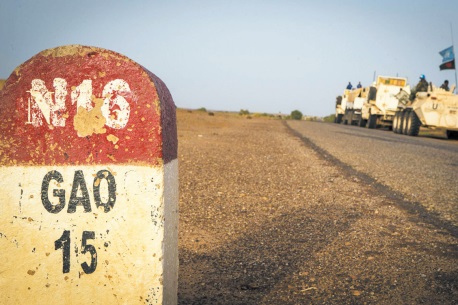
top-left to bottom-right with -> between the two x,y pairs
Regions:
0,0 -> 458,116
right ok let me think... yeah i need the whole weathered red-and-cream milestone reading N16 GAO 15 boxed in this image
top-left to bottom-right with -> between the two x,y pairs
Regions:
0,45 -> 178,304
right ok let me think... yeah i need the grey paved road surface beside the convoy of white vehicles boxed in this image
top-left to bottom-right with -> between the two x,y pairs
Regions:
287,121 -> 458,232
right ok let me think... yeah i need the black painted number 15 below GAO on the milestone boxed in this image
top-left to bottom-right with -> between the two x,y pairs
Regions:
54,230 -> 97,274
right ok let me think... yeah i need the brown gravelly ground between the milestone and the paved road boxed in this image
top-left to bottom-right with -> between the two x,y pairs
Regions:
177,109 -> 458,305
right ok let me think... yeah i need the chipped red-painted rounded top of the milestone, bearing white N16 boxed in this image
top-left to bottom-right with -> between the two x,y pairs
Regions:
0,46 -> 176,165
